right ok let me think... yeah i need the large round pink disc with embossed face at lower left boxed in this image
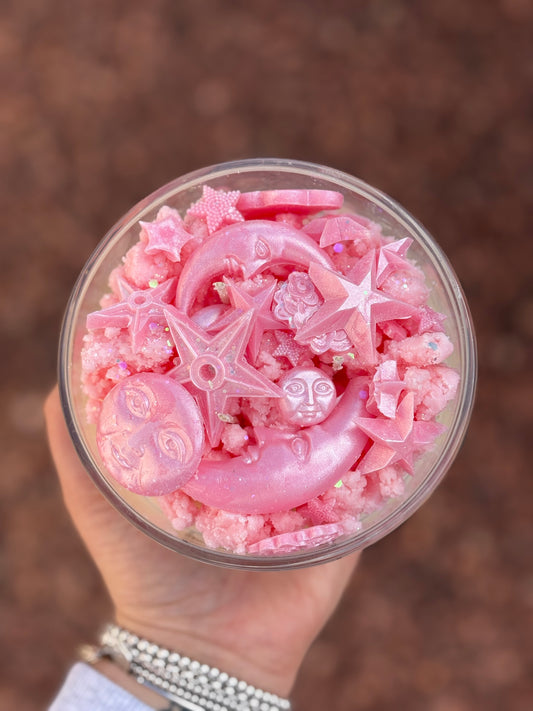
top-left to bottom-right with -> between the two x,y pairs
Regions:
96,373 -> 204,496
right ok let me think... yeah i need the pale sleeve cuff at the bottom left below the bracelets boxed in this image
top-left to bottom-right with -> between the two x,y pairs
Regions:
48,662 -> 152,711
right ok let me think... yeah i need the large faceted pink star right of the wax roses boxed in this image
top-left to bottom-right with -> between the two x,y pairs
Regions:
296,250 -> 415,364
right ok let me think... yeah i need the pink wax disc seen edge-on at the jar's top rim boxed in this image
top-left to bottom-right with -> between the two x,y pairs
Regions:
237,190 -> 344,219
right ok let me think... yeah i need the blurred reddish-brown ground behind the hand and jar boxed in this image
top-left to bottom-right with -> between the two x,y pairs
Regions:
0,0 -> 533,711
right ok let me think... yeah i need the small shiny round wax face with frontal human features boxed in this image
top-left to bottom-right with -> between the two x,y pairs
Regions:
278,367 -> 336,427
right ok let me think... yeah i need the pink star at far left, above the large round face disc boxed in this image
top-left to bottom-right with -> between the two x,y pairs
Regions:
87,277 -> 177,350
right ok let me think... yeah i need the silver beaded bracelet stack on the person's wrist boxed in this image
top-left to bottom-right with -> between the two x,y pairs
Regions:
80,624 -> 291,711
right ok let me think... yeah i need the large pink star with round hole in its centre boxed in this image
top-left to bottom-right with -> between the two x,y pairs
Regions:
165,306 -> 281,447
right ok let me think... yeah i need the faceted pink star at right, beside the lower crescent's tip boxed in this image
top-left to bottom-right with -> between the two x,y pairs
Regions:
356,393 -> 444,474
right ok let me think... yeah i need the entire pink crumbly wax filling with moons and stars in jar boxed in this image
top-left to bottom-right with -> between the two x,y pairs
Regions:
82,185 -> 459,556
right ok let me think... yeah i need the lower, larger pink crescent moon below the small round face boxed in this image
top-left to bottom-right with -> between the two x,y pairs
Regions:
183,378 -> 368,514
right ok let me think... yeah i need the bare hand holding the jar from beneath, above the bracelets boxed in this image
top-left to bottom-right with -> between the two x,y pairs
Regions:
45,388 -> 358,696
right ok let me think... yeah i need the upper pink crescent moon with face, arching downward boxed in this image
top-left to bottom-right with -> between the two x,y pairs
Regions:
176,220 -> 333,314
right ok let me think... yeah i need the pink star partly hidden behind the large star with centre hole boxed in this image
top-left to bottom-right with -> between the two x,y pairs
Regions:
223,277 -> 283,363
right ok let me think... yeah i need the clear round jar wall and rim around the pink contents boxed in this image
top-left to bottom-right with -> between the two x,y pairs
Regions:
59,159 -> 476,570
